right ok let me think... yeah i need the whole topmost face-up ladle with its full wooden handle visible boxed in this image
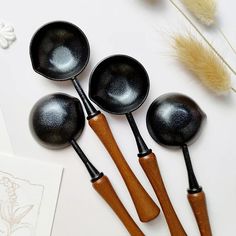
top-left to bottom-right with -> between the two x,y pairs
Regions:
30,21 -> 160,222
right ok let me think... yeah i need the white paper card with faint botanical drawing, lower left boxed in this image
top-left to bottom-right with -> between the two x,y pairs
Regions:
0,155 -> 63,236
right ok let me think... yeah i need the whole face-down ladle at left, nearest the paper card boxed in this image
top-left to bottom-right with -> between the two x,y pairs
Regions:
30,93 -> 144,236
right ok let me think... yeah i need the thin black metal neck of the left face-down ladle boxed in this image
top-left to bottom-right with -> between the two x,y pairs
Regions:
70,139 -> 103,182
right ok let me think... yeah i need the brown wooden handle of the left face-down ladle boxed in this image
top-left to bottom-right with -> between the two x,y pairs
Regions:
93,175 -> 144,236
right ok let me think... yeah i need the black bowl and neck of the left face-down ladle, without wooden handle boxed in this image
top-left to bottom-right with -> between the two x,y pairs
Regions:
29,93 -> 103,181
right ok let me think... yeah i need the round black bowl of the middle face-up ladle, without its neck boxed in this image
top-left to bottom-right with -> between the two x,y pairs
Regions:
89,55 -> 149,115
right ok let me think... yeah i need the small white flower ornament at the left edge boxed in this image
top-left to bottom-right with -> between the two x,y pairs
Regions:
0,23 -> 16,49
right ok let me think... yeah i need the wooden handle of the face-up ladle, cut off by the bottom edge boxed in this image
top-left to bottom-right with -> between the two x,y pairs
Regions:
139,153 -> 187,236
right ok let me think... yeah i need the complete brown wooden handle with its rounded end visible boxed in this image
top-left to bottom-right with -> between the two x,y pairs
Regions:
89,114 -> 160,222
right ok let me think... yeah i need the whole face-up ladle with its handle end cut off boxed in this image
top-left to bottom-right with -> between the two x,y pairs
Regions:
89,55 -> 186,235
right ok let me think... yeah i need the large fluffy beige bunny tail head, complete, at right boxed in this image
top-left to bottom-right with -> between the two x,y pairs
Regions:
174,35 -> 231,94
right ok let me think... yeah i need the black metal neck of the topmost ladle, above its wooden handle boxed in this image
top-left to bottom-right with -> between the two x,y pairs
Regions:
72,77 -> 100,120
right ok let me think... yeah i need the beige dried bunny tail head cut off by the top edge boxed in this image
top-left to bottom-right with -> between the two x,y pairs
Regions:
181,0 -> 216,25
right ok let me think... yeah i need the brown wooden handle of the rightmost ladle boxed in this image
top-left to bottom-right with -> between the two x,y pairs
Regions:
188,191 -> 212,236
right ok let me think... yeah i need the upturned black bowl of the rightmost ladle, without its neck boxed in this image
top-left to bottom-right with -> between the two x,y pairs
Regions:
146,93 -> 206,146
